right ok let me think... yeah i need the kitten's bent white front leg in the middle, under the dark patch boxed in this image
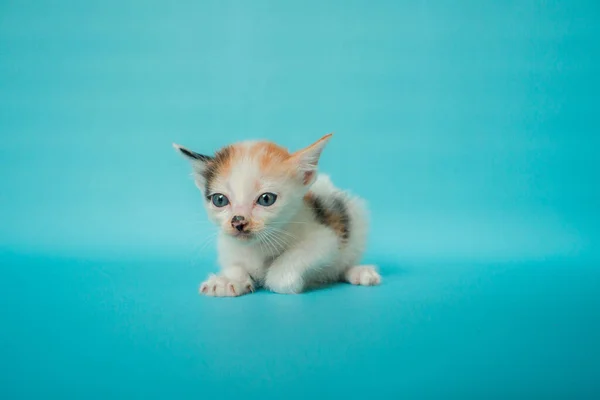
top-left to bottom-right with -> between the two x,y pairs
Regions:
265,229 -> 339,294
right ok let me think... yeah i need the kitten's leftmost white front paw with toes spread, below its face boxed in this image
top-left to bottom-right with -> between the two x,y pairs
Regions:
198,266 -> 254,297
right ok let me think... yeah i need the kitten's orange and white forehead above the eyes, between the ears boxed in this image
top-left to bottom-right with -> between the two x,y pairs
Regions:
207,141 -> 290,194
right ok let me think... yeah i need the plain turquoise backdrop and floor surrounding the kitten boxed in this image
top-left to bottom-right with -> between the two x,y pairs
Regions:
0,0 -> 600,399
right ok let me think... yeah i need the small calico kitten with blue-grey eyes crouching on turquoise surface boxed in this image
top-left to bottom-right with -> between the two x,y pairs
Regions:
173,134 -> 381,296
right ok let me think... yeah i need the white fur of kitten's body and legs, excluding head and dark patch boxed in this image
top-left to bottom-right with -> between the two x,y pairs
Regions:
200,175 -> 381,296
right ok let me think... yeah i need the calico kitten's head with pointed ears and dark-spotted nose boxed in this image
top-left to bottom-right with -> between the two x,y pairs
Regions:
173,134 -> 332,240
